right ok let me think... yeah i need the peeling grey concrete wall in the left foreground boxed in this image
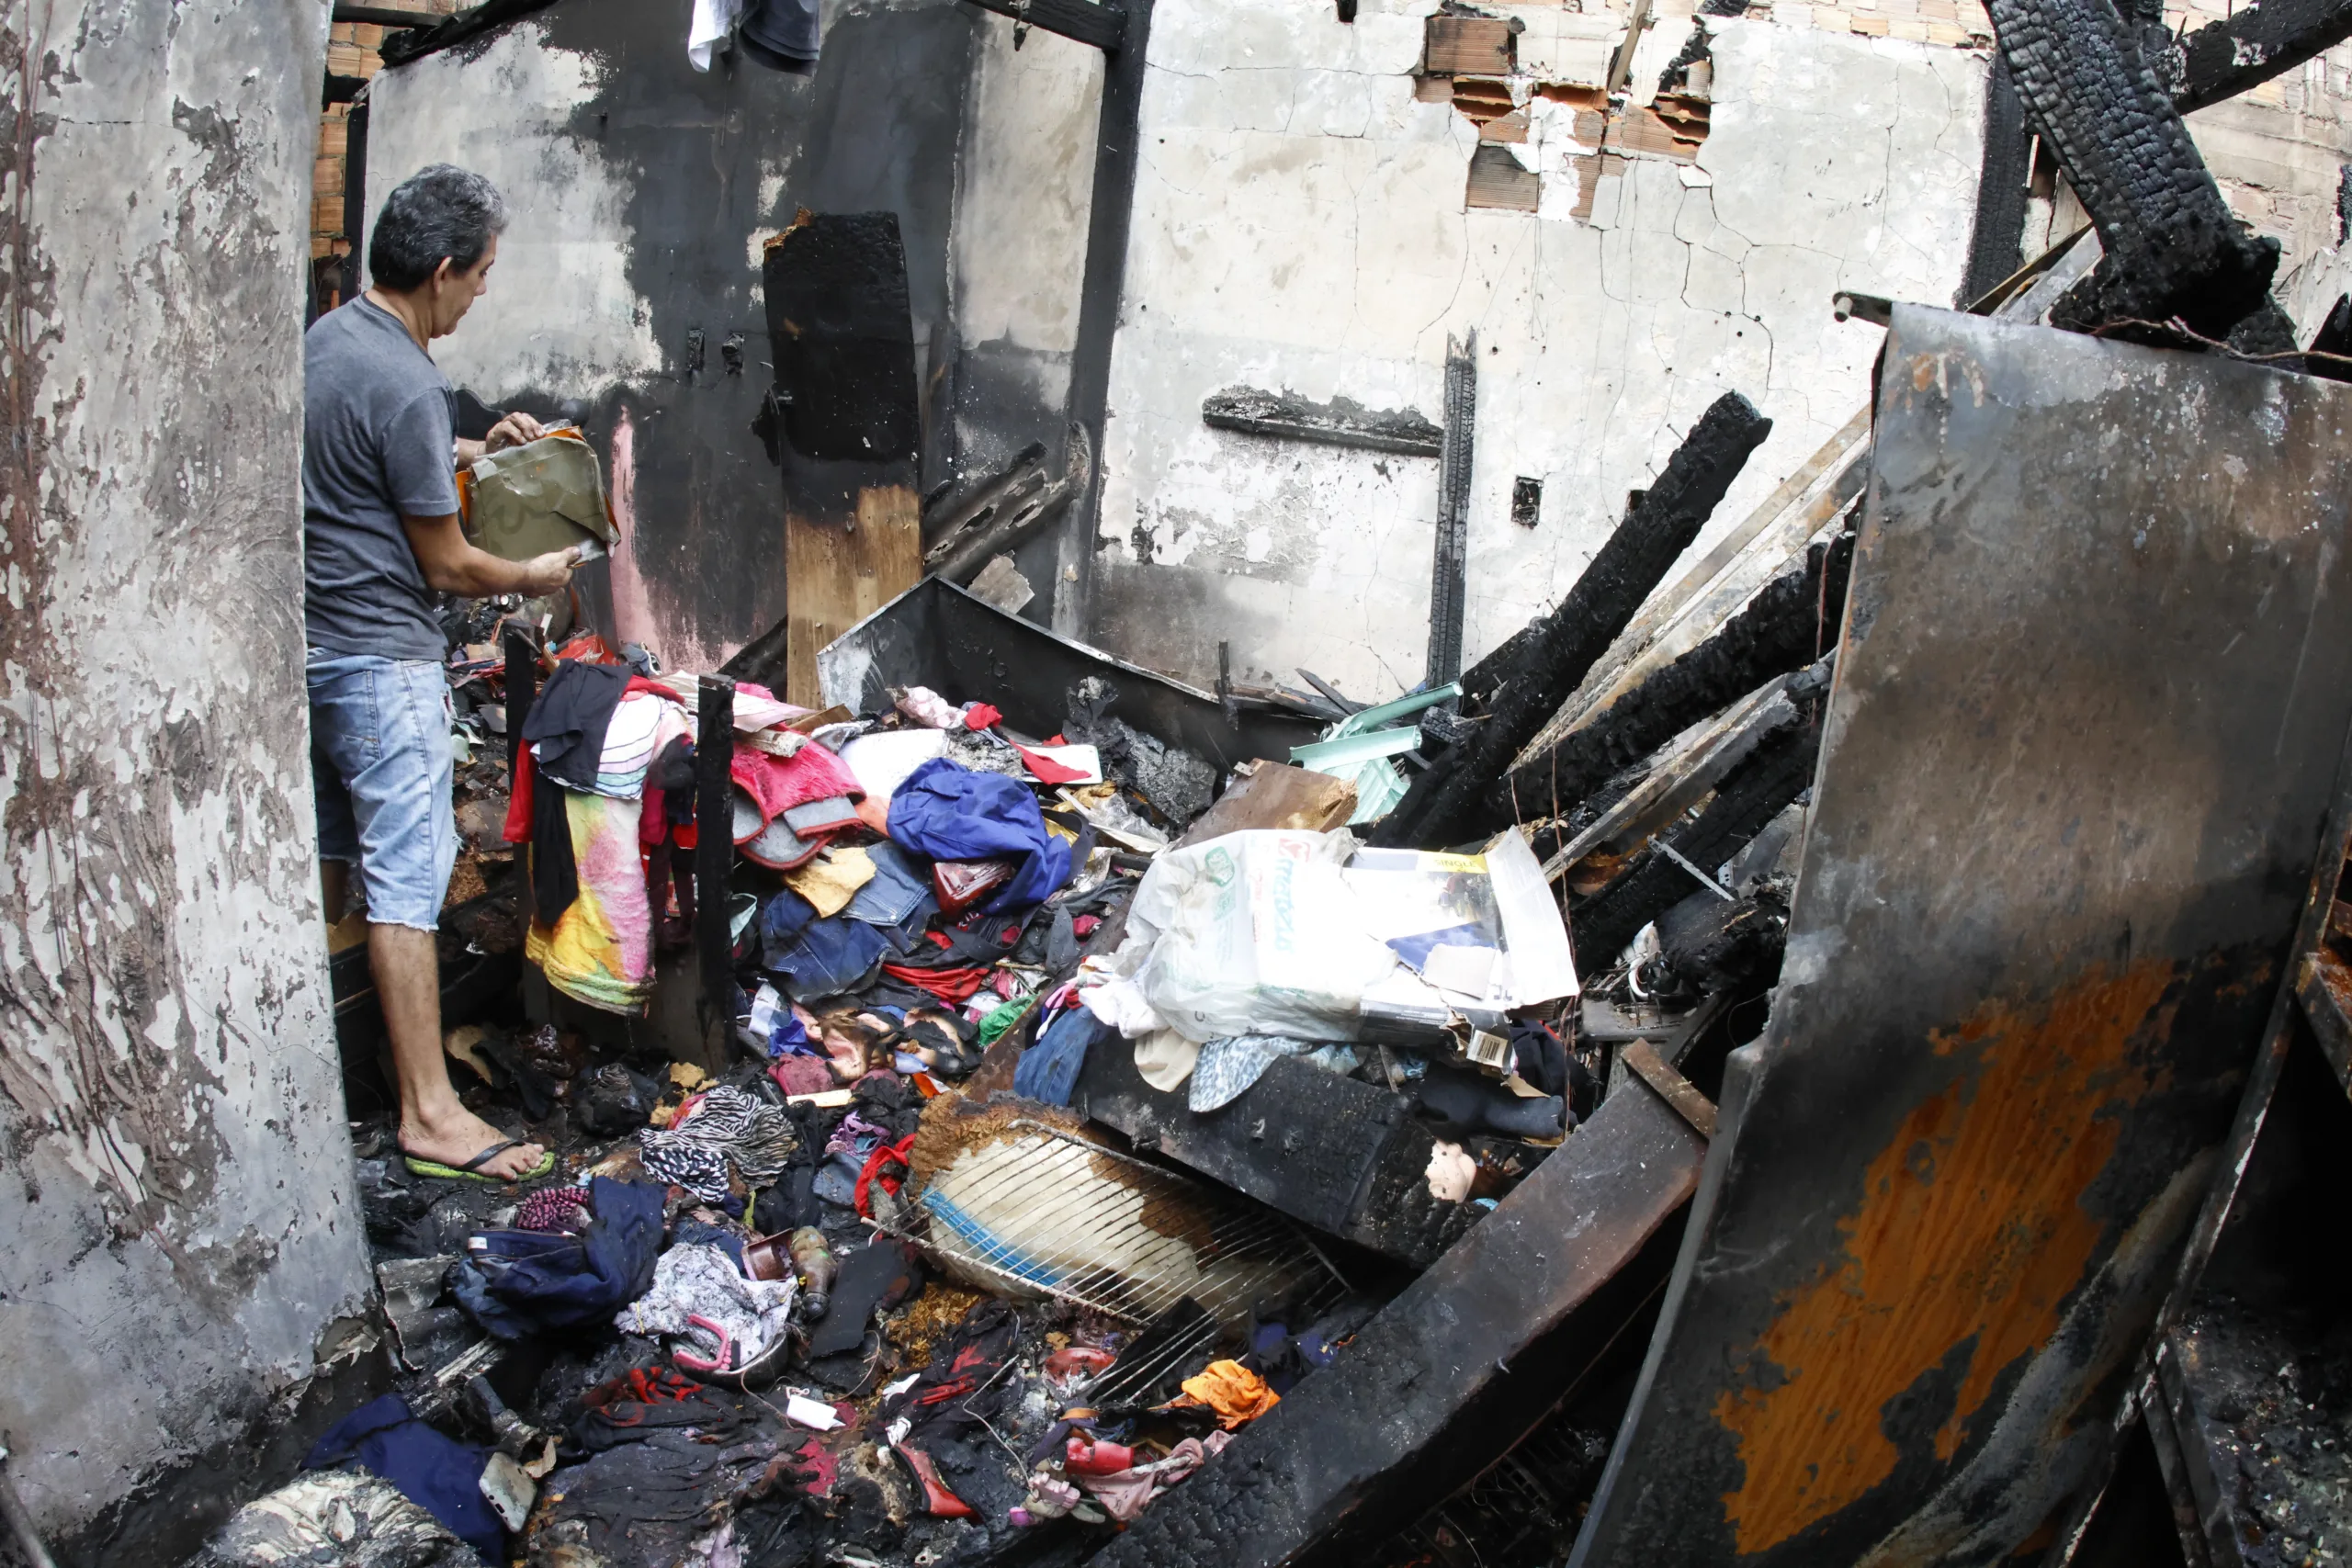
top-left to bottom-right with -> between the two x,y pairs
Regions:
0,0 -> 367,1561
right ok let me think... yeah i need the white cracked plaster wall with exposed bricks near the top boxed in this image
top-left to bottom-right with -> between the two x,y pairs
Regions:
1087,0 -> 1985,701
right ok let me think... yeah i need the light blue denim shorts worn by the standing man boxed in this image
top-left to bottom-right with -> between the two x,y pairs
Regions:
306,649 -> 457,931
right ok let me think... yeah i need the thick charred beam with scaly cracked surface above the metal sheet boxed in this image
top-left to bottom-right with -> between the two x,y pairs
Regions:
1990,0 -> 2279,339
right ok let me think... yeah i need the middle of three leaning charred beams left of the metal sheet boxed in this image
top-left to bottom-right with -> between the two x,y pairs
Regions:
1487,534 -> 1853,818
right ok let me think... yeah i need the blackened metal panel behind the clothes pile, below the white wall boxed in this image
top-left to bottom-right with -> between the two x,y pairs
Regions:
799,579 -> 1322,773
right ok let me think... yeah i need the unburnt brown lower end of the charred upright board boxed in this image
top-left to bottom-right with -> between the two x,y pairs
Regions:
778,484 -> 922,707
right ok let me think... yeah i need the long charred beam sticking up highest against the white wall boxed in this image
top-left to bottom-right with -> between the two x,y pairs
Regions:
1374,392 -> 1771,846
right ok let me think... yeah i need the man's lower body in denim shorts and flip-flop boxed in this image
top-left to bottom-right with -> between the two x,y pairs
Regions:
311,660 -> 546,1178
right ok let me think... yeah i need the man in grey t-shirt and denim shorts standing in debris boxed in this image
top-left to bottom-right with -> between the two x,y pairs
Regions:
301,164 -> 576,1180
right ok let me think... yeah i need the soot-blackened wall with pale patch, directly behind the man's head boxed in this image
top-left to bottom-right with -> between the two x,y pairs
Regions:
367,0 -> 983,668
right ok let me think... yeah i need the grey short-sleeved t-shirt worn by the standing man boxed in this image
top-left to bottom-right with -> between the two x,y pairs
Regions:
301,296 -> 457,663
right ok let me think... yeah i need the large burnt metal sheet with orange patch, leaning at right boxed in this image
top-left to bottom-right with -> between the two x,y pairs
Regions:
1571,306 -> 2352,1568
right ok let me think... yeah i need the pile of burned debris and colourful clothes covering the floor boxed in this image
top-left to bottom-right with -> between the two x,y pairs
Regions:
187,359 -> 1851,1568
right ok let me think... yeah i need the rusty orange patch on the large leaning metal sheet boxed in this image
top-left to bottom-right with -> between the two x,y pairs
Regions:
1714,959 -> 2183,1556
